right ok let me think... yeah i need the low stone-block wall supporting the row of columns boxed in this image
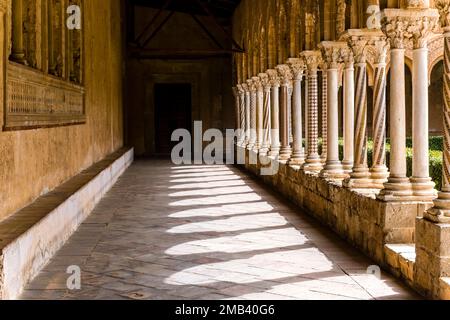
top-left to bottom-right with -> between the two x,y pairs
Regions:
241,149 -> 432,276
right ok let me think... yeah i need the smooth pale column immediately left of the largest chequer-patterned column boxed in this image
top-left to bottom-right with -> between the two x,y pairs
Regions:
289,59 -> 305,165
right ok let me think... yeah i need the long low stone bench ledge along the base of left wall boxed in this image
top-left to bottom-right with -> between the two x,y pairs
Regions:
0,149 -> 134,299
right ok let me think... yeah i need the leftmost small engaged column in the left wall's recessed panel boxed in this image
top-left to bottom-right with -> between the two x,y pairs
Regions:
11,0 -> 26,64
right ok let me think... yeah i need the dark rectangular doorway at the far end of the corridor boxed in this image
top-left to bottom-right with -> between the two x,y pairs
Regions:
155,83 -> 192,155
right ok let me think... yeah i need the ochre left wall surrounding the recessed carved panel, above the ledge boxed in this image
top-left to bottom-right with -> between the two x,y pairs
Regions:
0,0 -> 123,219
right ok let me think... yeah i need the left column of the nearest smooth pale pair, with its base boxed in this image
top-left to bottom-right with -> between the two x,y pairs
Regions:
378,14 -> 412,201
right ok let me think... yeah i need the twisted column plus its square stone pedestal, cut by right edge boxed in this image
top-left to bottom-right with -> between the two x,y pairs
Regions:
414,0 -> 450,299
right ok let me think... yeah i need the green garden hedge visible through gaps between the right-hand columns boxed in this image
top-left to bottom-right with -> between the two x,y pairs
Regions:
319,136 -> 444,190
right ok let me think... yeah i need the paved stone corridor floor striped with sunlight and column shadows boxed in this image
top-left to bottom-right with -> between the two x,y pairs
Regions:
21,160 -> 419,300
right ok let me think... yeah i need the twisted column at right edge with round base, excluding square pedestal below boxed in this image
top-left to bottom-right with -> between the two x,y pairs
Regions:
425,7 -> 450,223
